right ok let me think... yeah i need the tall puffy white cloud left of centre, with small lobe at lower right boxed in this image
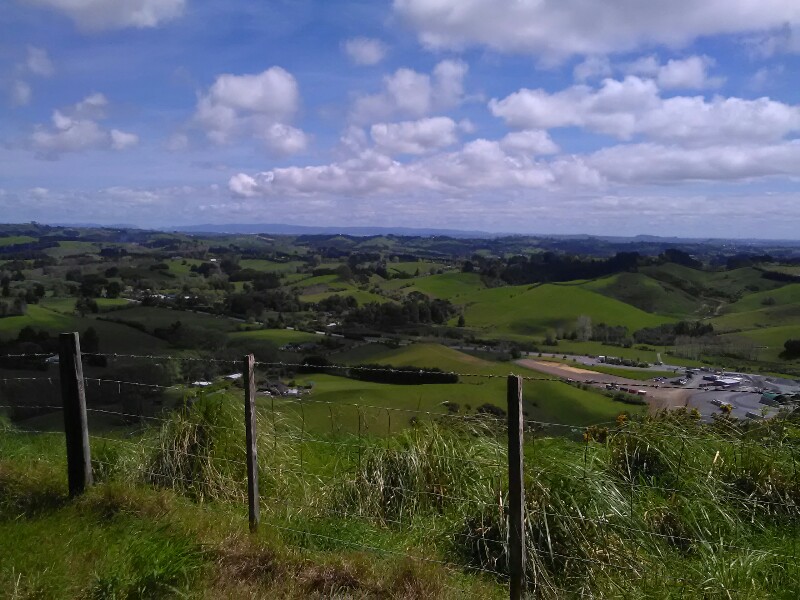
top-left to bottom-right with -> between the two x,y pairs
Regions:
194,67 -> 308,155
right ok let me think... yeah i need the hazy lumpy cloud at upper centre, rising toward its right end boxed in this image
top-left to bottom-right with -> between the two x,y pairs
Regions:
351,60 -> 468,123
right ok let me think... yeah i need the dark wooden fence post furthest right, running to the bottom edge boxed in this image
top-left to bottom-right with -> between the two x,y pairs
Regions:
508,375 -> 525,600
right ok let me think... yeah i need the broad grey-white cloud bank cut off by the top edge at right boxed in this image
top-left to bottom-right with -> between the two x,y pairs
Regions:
394,0 -> 800,60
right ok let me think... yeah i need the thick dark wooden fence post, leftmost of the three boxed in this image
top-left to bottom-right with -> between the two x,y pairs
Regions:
58,333 -> 92,497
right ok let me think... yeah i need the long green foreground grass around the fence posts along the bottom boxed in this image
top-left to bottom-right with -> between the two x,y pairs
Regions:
0,404 -> 800,599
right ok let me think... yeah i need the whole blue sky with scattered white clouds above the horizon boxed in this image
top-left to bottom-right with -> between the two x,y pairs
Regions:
0,0 -> 800,239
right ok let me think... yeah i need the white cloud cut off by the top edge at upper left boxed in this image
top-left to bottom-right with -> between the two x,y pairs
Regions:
19,0 -> 186,31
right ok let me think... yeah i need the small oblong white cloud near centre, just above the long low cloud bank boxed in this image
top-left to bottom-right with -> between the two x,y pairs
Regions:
370,117 -> 458,155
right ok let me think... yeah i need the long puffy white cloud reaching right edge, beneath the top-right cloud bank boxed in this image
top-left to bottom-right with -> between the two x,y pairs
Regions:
489,76 -> 800,146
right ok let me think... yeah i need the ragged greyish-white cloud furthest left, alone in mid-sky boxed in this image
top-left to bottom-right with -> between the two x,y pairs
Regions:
29,94 -> 139,159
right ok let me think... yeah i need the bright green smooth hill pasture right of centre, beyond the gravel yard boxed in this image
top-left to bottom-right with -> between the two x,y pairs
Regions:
464,284 -> 674,336
